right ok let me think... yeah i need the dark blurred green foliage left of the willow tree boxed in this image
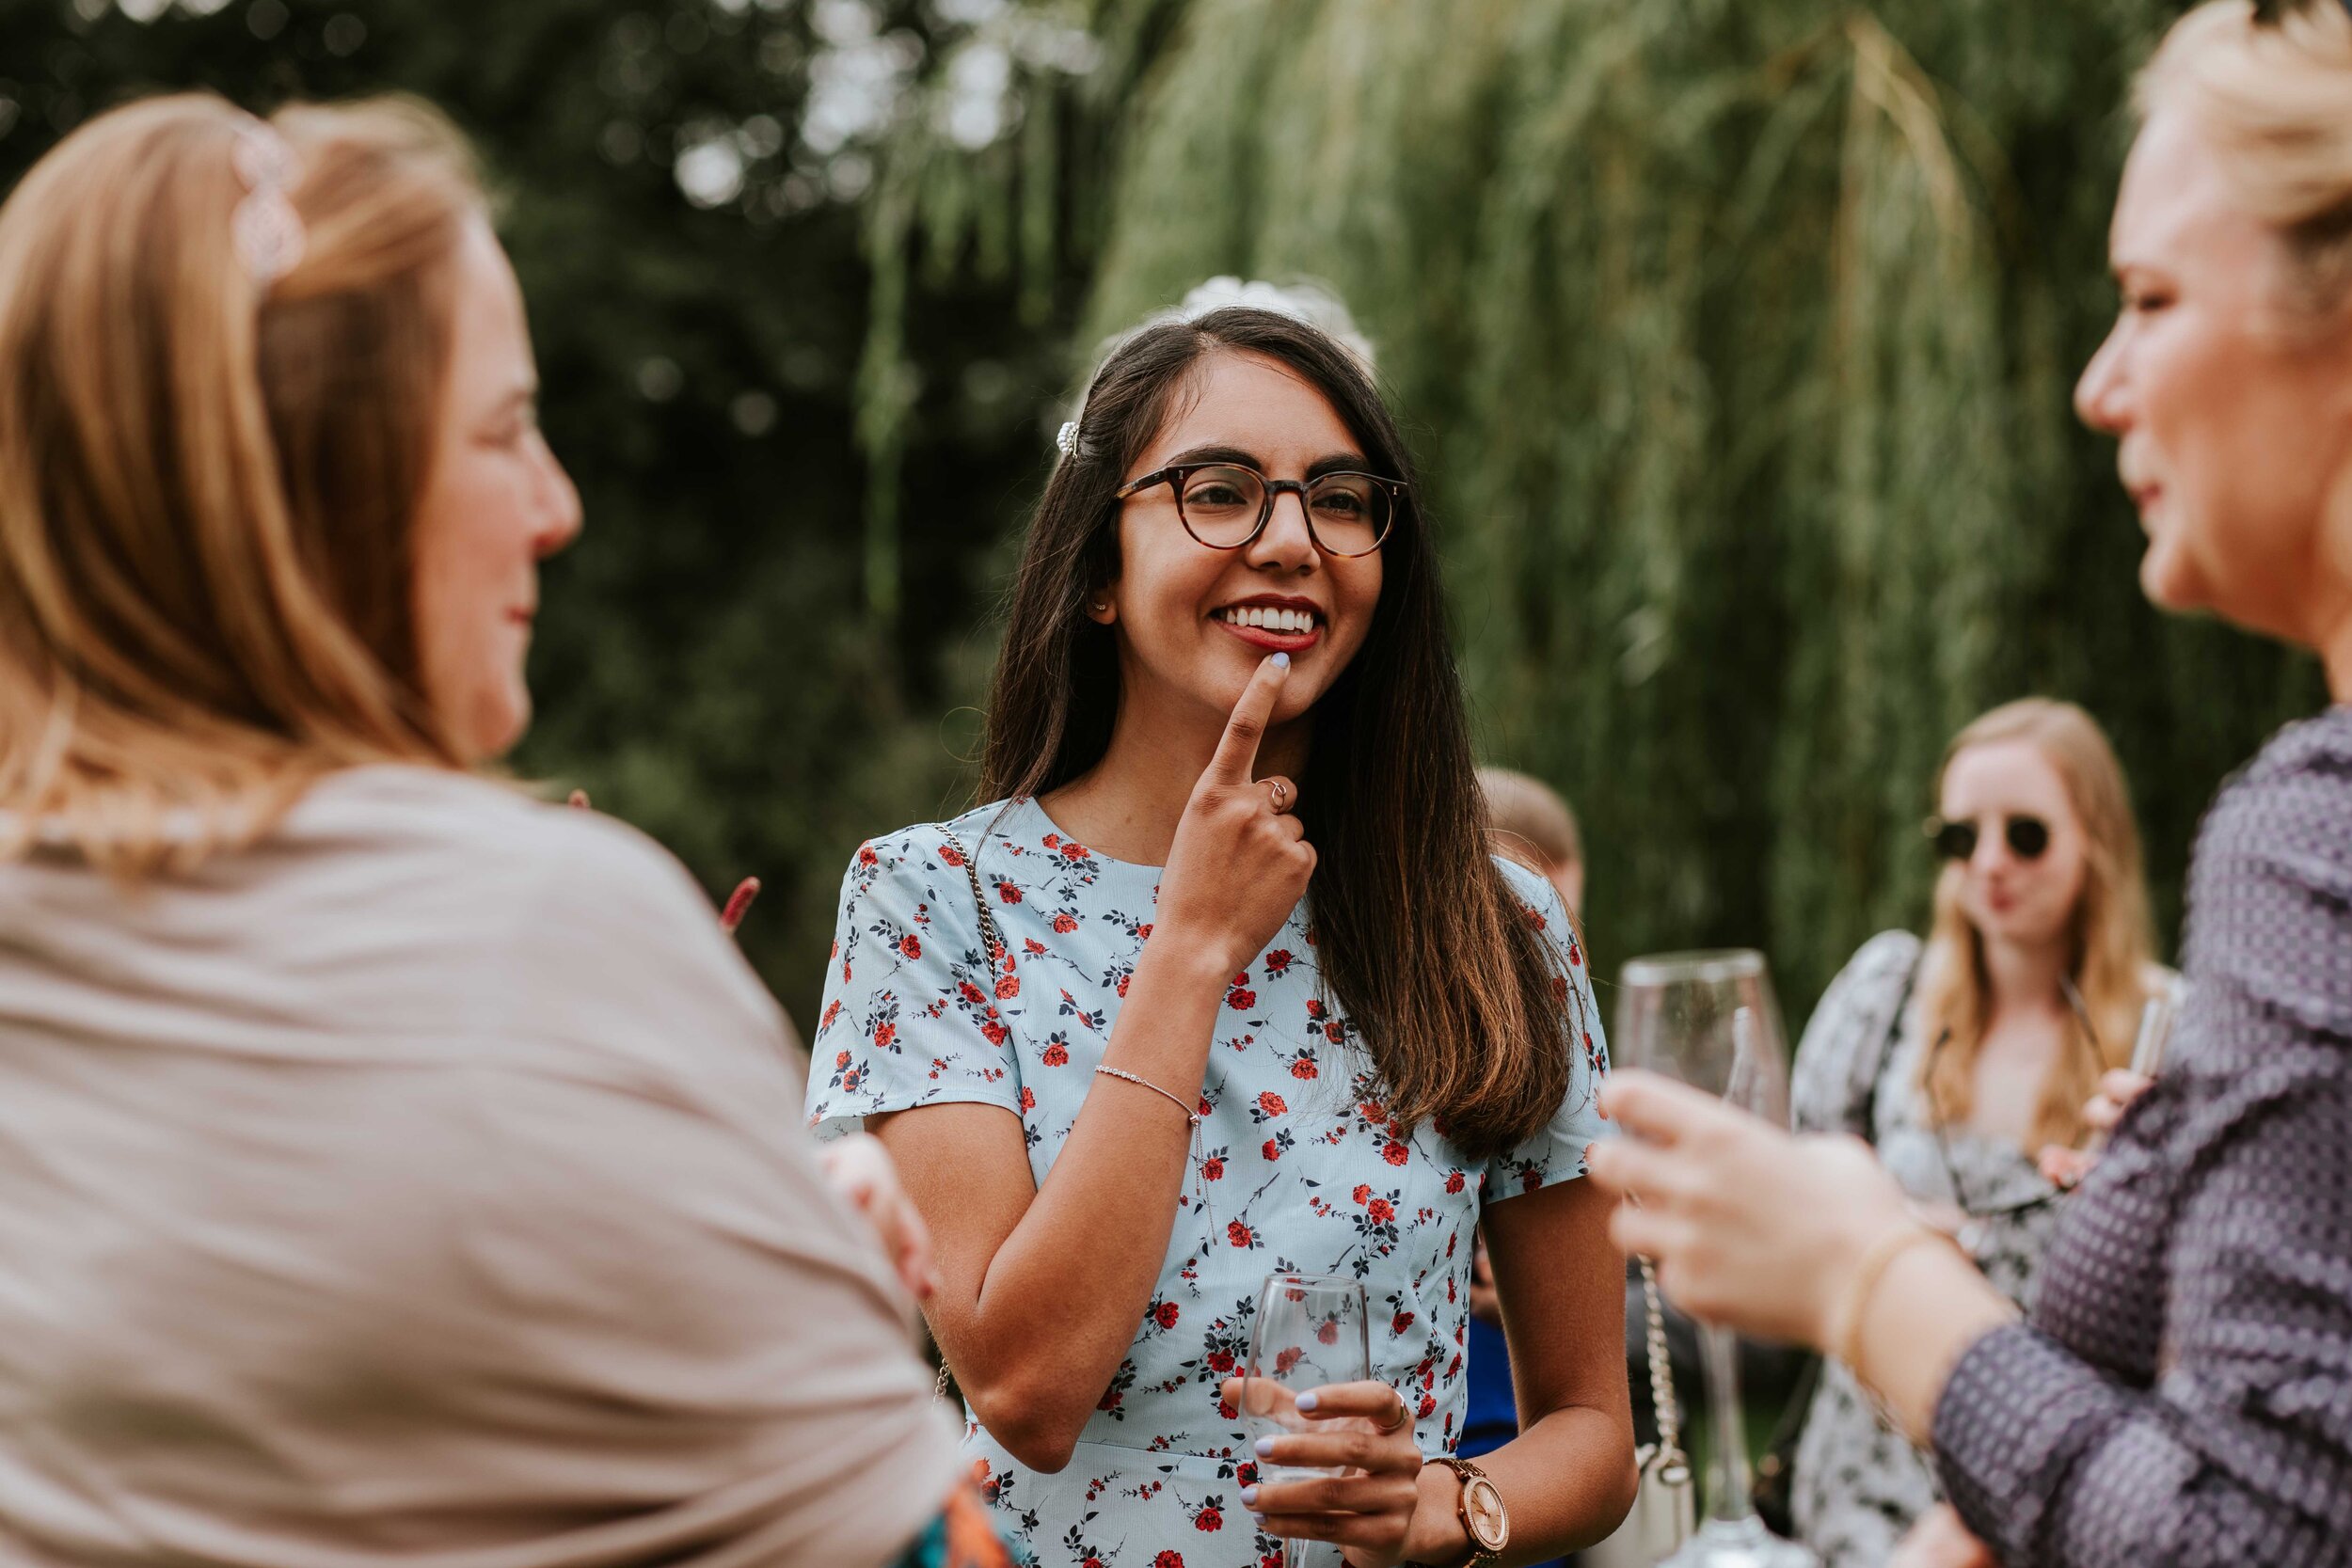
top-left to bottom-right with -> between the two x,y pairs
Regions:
0,0 -> 1044,1022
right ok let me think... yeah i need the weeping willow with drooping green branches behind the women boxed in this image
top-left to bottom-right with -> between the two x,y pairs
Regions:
866,0 -> 2322,1006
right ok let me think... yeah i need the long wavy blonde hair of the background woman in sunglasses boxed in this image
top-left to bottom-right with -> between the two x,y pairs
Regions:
1919,698 -> 2162,1149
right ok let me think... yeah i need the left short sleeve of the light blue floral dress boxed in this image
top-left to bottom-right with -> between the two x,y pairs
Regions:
807,825 -> 1021,1138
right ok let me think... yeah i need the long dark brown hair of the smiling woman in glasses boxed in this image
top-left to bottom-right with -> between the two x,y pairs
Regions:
981,308 -> 1585,1157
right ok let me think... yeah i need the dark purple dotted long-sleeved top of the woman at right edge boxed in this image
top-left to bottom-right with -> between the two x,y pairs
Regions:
1933,707 -> 2352,1568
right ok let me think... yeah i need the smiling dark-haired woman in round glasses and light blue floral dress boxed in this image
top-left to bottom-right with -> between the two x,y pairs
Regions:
809,291 -> 1632,1568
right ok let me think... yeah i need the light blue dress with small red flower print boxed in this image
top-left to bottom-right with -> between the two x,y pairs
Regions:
809,800 -> 1607,1568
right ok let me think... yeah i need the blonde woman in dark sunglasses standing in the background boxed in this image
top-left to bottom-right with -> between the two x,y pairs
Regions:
1790,698 -> 2169,1568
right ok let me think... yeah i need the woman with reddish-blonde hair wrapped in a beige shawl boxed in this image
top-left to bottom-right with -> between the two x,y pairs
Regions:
0,96 -> 1002,1568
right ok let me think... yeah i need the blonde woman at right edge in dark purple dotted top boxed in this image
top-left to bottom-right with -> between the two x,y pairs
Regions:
1593,0 -> 2352,1568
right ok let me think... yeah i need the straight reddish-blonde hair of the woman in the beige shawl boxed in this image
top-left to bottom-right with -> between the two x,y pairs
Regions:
0,94 -> 485,877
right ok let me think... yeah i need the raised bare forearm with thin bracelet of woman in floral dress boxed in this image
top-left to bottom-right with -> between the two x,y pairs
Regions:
953,942 -> 1226,1446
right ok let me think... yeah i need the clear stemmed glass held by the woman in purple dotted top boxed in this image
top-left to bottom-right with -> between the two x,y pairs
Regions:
1609,950 -> 1820,1568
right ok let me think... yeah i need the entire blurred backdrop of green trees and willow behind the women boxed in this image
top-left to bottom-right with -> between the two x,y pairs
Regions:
0,0 -> 2324,1022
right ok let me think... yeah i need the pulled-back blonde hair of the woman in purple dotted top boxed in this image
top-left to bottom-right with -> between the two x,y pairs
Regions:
2138,0 -> 2352,325
